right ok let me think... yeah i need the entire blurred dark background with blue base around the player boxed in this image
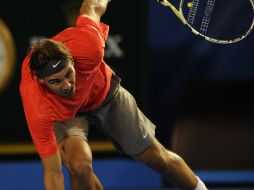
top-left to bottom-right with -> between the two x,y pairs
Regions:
0,0 -> 254,190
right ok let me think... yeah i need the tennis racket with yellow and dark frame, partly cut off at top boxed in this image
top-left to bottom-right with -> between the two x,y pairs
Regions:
156,0 -> 254,44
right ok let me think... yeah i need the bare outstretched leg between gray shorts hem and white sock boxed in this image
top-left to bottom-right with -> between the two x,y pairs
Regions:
135,139 -> 198,190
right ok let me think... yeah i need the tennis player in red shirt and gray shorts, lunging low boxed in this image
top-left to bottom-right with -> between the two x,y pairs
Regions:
20,0 -> 206,190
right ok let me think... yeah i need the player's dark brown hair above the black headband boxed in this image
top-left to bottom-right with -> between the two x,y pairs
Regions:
29,39 -> 72,77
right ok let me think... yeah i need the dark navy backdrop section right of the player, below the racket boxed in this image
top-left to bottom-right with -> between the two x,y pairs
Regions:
148,1 -> 254,148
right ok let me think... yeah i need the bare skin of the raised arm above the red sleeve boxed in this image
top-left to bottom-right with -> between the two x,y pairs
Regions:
80,0 -> 109,21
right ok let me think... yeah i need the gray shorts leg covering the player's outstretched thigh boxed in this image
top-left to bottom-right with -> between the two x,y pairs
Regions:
95,86 -> 155,156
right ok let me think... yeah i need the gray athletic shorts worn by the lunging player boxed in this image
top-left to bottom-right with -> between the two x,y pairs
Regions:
54,75 -> 155,156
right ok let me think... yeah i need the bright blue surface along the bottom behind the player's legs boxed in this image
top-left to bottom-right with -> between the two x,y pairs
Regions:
0,159 -> 254,190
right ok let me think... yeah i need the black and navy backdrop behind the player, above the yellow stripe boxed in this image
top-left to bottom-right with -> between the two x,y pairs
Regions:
0,0 -> 254,169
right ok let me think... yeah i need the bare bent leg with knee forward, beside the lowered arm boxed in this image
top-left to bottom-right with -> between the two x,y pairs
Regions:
60,136 -> 103,190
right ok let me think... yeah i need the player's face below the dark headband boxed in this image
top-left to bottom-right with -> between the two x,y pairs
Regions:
40,63 -> 76,97
